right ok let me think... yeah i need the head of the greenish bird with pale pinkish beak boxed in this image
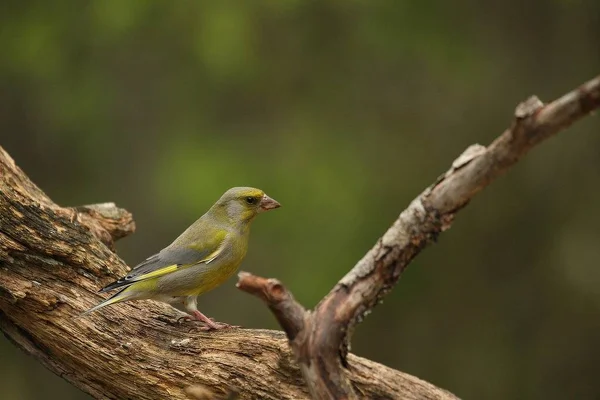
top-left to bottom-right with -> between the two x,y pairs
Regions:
215,187 -> 281,222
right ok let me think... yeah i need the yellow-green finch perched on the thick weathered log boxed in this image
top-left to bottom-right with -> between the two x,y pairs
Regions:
80,187 -> 281,330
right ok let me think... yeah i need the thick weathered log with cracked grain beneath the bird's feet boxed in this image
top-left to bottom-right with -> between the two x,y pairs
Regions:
0,148 -> 455,400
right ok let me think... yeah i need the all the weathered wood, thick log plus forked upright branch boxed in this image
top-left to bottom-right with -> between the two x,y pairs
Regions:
0,73 -> 600,399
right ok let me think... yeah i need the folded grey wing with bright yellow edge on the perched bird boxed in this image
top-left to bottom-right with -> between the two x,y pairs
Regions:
100,228 -> 227,293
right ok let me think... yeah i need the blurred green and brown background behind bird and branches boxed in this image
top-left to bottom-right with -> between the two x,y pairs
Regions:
0,0 -> 600,400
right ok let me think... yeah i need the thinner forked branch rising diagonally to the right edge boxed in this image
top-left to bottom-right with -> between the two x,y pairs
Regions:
233,76 -> 600,399
